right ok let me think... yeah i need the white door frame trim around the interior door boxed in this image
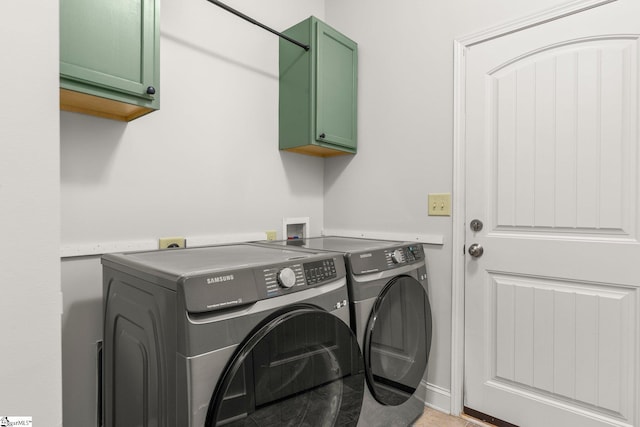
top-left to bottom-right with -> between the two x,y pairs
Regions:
451,0 -> 617,415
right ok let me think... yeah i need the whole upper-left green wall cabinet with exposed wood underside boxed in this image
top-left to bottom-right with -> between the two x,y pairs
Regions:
60,0 -> 160,121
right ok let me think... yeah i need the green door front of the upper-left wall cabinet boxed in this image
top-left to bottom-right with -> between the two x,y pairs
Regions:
60,0 -> 159,99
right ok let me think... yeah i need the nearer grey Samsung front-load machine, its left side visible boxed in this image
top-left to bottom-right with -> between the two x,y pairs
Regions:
102,244 -> 366,427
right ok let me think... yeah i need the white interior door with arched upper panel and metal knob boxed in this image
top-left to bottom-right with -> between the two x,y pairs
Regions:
464,0 -> 640,427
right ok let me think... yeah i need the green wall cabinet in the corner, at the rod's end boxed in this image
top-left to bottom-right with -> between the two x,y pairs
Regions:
279,16 -> 358,157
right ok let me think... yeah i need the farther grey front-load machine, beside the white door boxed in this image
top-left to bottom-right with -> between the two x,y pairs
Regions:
260,236 -> 432,427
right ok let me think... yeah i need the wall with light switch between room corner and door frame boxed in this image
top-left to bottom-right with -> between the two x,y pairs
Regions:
324,0 -> 567,410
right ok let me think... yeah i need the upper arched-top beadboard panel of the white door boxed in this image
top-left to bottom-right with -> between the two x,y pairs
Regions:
487,37 -> 638,234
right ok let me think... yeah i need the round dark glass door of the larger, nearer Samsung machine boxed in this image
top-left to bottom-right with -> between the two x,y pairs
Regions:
205,305 -> 365,427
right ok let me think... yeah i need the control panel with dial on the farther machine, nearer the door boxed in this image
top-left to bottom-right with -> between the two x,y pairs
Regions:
349,244 -> 424,274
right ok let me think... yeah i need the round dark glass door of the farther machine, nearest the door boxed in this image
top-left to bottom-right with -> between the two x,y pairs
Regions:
363,276 -> 431,406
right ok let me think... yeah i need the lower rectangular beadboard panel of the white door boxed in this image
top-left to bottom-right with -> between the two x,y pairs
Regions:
487,273 -> 634,417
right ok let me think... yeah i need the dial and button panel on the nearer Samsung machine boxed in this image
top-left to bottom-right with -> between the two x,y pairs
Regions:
261,258 -> 338,298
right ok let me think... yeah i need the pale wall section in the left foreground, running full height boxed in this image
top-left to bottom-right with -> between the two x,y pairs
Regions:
0,0 -> 62,426
